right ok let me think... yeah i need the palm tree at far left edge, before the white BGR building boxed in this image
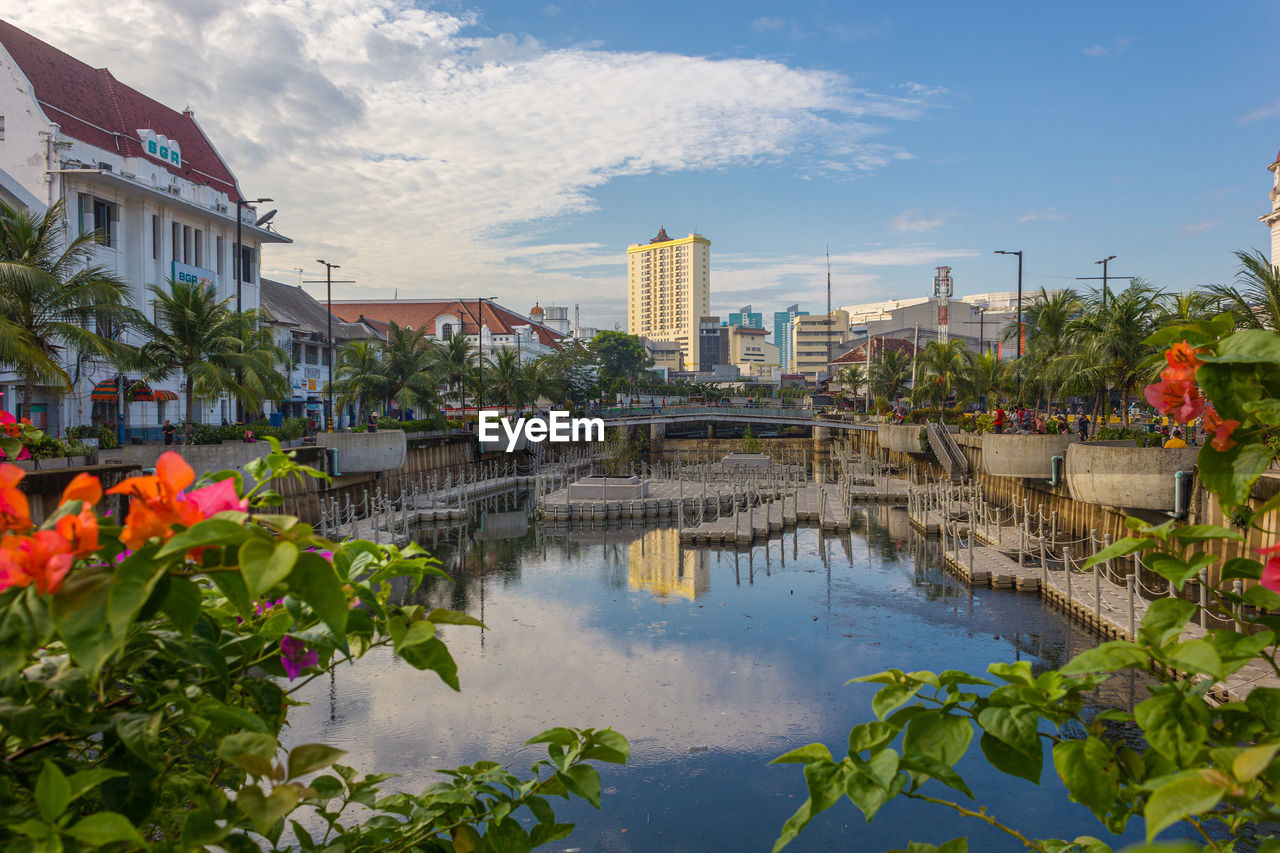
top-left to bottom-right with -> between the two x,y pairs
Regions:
0,201 -> 141,407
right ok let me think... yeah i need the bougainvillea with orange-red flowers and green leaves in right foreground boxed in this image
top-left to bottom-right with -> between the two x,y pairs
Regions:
774,315 -> 1280,853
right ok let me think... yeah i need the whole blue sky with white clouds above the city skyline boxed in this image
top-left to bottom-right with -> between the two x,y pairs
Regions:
3,0 -> 1280,329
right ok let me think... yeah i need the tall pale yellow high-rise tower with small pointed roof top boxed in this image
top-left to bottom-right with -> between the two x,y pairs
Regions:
627,228 -> 712,364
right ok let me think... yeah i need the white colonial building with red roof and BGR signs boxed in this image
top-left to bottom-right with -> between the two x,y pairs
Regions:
0,20 -> 289,438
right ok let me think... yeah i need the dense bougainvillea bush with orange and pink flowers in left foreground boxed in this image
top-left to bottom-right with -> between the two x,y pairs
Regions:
0,441 -> 628,853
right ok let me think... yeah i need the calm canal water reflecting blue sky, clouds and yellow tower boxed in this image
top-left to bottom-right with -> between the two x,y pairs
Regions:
288,506 -> 1167,852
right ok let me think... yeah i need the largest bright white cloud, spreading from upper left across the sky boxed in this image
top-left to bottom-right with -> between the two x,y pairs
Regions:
5,0 -> 924,325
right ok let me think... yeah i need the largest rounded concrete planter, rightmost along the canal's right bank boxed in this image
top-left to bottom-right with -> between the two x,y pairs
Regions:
1066,442 -> 1199,512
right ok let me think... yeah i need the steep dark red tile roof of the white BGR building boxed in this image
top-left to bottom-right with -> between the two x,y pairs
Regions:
0,20 -> 239,204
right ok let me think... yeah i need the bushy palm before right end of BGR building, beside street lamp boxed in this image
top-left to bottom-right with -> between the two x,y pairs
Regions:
133,279 -> 277,438
